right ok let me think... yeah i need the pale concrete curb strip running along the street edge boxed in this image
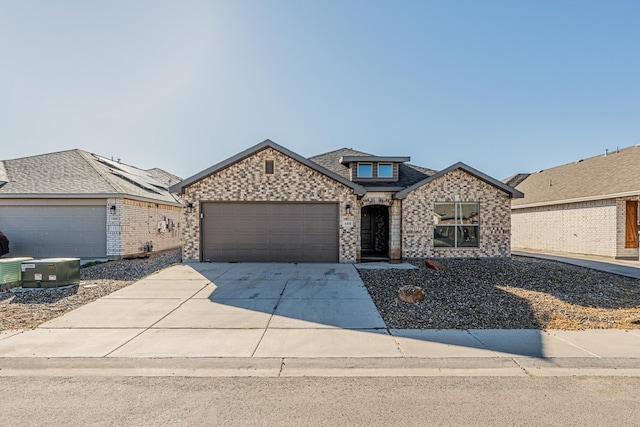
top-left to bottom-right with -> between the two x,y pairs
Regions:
0,357 -> 640,378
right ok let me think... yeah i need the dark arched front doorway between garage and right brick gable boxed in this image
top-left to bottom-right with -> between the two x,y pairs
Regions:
360,205 -> 389,261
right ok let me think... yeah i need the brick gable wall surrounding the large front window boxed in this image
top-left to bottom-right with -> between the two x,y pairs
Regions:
402,169 -> 511,258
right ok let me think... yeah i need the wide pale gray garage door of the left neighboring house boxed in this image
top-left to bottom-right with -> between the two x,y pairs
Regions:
0,204 -> 107,258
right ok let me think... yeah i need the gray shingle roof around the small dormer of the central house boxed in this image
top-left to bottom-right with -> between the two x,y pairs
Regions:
309,148 -> 437,189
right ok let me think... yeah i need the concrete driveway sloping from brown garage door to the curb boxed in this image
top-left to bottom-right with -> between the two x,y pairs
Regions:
0,263 -> 401,357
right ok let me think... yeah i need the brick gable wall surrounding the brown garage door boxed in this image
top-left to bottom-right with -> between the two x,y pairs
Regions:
183,147 -> 359,262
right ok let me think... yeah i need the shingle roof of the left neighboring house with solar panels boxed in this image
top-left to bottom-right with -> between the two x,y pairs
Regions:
0,149 -> 180,205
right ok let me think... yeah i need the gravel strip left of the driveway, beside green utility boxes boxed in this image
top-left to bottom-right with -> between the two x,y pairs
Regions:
0,249 -> 182,331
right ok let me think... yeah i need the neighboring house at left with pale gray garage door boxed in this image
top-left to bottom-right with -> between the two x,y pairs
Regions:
0,150 -> 183,259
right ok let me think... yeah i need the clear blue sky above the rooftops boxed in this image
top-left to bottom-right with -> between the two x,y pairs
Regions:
0,0 -> 640,179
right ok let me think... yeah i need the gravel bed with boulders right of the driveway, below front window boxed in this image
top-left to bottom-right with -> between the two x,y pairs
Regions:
360,256 -> 640,330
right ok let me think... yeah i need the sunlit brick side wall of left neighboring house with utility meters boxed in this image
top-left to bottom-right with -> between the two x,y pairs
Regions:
107,199 -> 184,258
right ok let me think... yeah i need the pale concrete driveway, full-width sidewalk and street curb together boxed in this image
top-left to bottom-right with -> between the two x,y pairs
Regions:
0,263 -> 640,376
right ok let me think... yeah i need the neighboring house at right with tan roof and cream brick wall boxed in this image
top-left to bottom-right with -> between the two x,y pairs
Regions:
507,146 -> 640,260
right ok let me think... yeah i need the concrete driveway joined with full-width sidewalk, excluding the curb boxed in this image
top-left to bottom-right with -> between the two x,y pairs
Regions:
0,263 -> 640,360
